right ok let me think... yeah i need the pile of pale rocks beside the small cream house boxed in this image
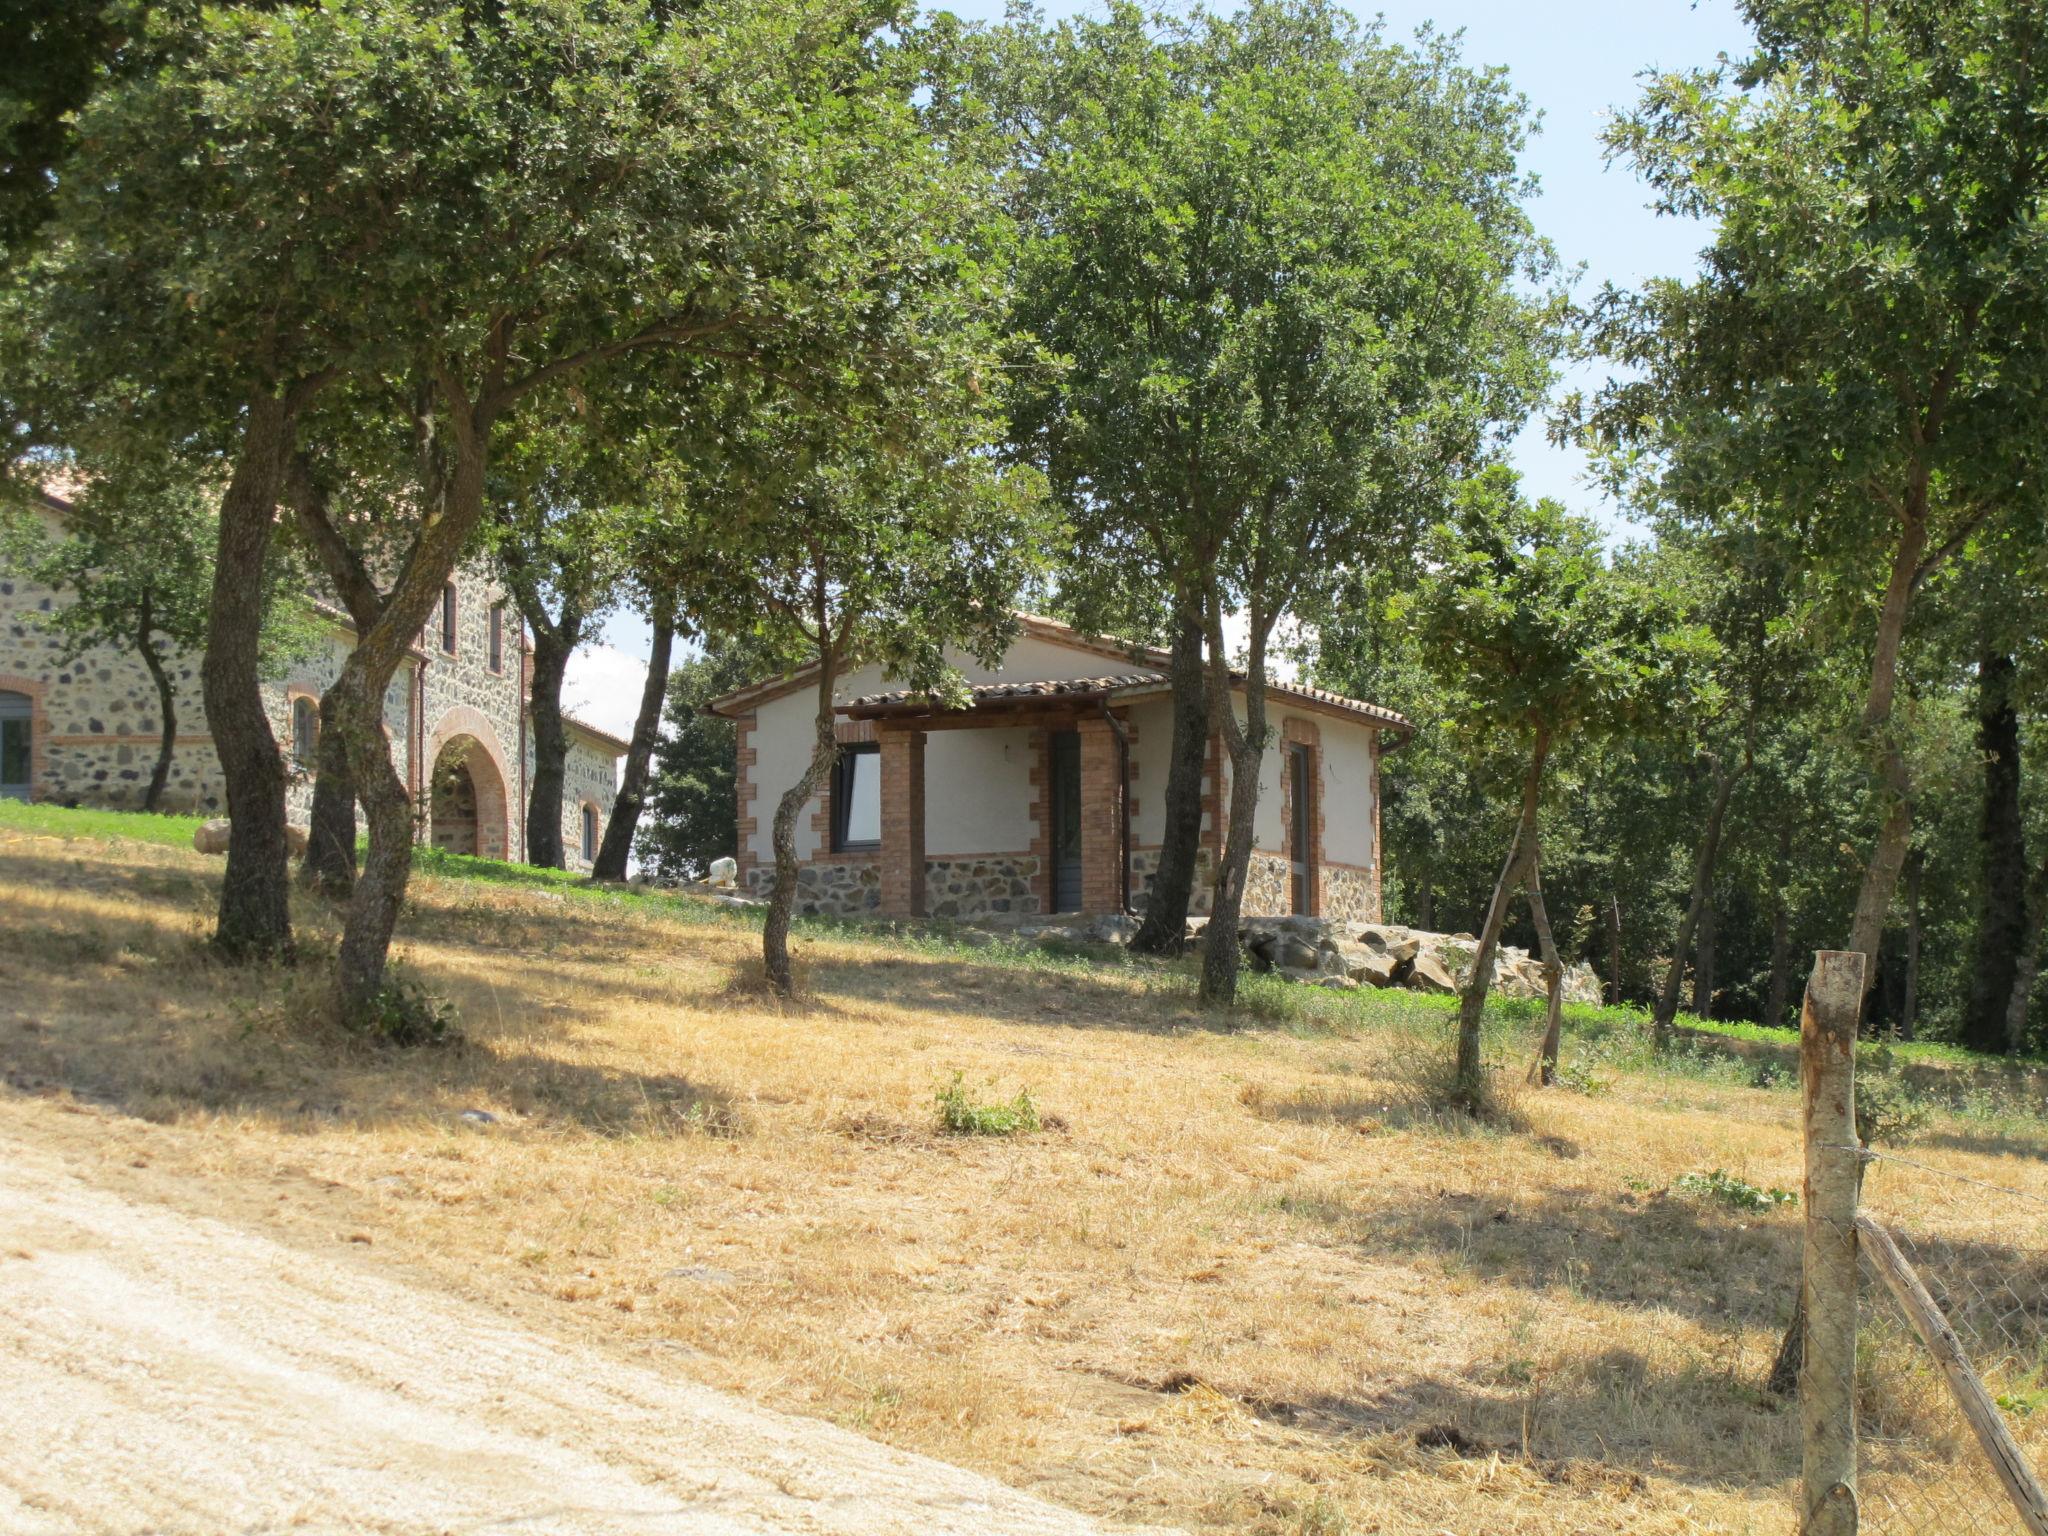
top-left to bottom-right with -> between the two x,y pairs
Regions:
1239,918 -> 1599,1004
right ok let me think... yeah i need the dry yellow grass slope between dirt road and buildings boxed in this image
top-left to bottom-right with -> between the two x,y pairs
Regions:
0,829 -> 2048,1536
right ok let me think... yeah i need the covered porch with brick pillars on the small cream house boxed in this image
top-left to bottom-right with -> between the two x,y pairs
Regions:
829,674 -> 1165,918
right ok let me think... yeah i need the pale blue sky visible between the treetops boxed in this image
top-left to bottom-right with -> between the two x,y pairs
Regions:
567,0 -> 1749,735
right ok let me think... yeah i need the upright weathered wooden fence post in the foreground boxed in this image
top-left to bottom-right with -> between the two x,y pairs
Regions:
1798,950 -> 1864,1536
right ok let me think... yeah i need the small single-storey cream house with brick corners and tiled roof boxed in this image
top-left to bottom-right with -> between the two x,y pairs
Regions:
711,616 -> 1413,922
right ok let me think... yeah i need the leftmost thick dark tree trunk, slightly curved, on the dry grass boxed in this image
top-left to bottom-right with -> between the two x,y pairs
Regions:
199,391 -> 295,961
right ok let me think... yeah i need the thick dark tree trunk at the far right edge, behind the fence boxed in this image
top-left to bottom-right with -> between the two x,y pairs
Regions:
1962,651 -> 2028,1051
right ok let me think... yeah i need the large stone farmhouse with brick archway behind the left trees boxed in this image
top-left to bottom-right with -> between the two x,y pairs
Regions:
0,492 -> 627,868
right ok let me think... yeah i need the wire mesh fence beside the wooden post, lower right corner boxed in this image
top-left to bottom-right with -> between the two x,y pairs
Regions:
1855,1153 -> 2048,1536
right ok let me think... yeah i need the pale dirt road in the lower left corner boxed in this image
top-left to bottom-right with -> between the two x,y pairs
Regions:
0,1133 -> 1155,1536
